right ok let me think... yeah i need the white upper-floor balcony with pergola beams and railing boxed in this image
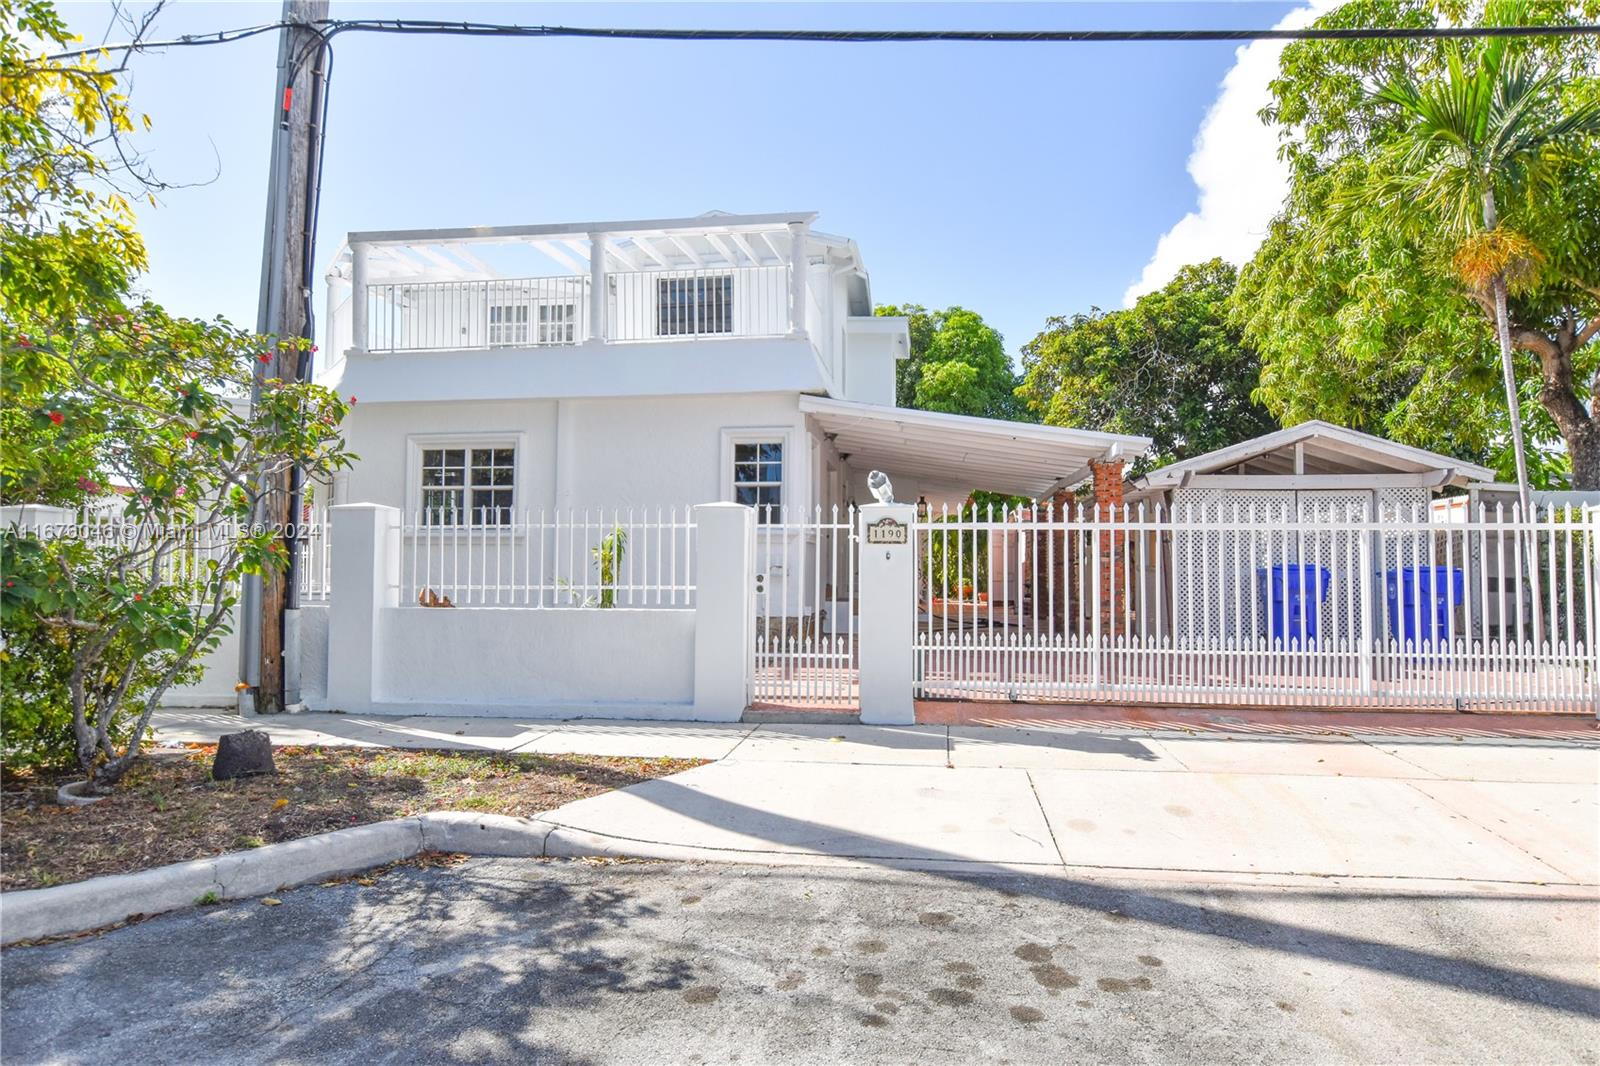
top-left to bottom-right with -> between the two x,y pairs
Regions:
328,213 -> 832,355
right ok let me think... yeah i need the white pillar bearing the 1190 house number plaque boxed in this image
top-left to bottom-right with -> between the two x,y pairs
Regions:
856,504 -> 917,725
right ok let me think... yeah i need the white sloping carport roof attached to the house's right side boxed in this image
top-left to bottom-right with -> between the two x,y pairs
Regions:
800,395 -> 1150,498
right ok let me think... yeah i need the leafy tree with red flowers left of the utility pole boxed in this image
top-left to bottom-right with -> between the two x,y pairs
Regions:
0,0 -> 349,781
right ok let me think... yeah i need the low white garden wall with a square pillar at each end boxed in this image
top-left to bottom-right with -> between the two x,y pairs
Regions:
320,504 -> 754,722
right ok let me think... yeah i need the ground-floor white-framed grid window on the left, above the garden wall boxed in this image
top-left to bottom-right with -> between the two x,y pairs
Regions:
413,440 -> 517,525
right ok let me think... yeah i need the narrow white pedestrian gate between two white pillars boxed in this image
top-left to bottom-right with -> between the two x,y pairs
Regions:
750,507 -> 859,709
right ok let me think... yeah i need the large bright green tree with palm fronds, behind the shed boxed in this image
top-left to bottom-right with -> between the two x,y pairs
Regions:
1234,0 -> 1600,487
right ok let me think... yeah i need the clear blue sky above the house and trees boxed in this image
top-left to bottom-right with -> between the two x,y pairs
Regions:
64,0 -> 1294,361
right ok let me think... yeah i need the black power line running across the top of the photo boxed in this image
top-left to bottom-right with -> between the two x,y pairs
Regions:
48,19 -> 1600,61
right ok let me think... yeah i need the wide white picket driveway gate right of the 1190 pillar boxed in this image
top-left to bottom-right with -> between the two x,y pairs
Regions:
914,506 -> 1600,711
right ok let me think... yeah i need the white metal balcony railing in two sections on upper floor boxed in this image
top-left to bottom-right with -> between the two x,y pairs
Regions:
366,266 -> 790,352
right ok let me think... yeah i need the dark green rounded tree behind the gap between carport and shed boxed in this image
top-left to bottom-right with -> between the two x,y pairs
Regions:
1018,259 -> 1277,469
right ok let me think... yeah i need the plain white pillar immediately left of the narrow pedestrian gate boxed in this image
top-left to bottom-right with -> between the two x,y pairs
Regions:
694,503 -> 755,722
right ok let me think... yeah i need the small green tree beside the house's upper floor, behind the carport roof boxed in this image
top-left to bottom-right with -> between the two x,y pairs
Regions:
877,304 -> 1032,421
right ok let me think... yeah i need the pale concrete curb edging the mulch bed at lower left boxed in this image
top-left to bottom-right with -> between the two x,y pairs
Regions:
0,812 -> 550,944
